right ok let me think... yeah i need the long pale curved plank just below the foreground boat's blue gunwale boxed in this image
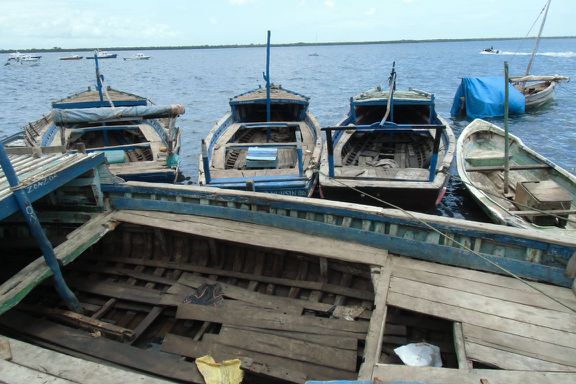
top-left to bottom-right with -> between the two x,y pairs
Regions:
114,211 -> 387,265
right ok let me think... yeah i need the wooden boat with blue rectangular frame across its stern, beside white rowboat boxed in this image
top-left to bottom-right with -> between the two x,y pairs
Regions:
320,66 -> 455,209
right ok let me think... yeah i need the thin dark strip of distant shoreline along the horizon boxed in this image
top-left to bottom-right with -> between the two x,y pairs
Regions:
0,36 -> 576,53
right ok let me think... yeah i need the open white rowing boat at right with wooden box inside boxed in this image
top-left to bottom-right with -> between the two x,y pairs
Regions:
457,119 -> 576,236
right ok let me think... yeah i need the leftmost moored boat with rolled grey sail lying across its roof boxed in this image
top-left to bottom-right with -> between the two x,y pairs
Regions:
4,56 -> 184,183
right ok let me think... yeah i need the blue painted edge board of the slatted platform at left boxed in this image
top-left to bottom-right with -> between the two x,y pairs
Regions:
0,153 -> 105,220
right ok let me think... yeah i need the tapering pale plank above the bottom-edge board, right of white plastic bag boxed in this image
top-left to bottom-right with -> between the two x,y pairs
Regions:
466,342 -> 576,377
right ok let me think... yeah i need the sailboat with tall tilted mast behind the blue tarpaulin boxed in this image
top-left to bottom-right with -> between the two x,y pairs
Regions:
510,0 -> 569,109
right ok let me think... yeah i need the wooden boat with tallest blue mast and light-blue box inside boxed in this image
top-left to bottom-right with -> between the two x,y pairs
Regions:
198,31 -> 322,196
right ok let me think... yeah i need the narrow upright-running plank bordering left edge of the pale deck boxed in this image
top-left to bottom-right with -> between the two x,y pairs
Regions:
358,259 -> 392,380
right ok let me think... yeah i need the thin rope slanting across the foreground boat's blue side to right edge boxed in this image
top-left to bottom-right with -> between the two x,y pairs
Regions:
318,171 -> 576,313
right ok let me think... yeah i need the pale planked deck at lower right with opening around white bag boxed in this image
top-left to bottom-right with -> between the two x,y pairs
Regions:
360,256 -> 576,383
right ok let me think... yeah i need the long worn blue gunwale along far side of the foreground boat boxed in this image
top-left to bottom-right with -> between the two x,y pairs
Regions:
103,185 -> 576,287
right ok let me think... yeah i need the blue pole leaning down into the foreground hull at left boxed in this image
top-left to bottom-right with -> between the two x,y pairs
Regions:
0,144 -> 82,313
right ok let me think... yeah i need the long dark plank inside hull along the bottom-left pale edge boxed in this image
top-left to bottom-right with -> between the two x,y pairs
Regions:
0,311 -> 203,383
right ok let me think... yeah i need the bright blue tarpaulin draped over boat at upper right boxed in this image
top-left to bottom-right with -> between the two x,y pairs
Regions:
450,76 -> 526,119
